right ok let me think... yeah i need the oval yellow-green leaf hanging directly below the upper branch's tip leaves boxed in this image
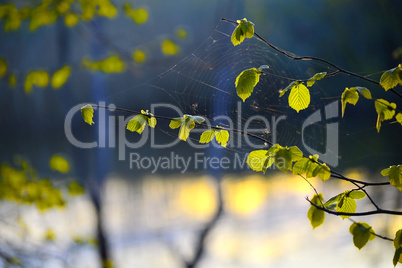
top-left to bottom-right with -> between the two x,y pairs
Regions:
235,68 -> 261,102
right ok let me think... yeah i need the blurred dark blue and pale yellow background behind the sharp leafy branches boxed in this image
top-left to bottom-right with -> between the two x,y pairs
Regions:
0,0 -> 402,267
